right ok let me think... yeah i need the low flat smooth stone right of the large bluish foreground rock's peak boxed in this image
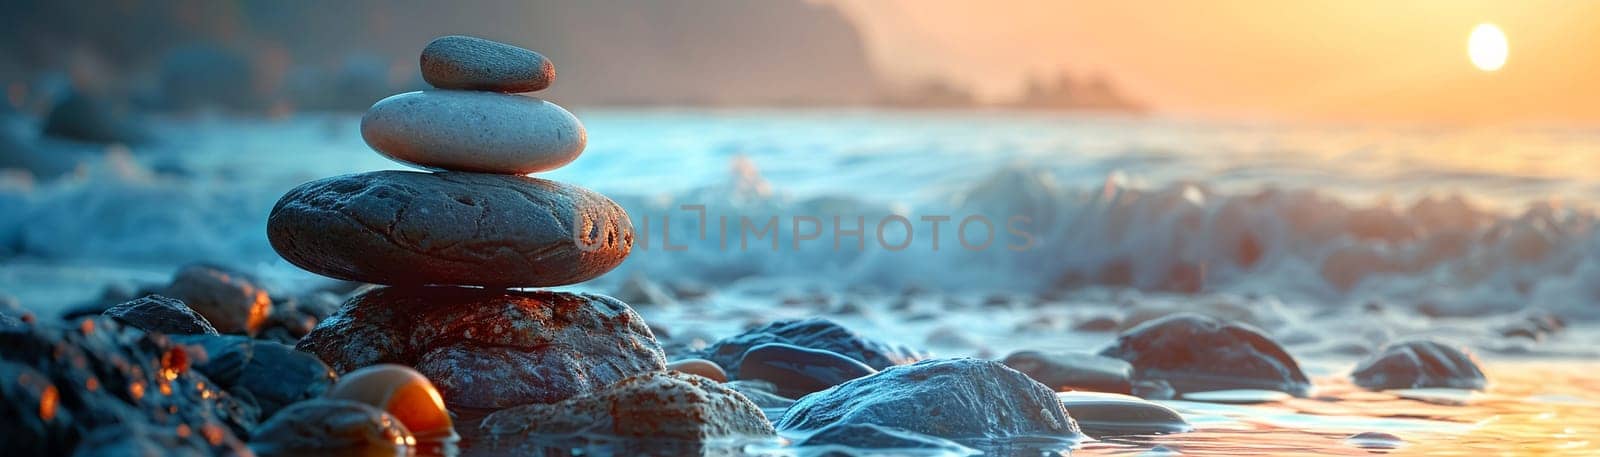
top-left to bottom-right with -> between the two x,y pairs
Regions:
1056,391 -> 1194,438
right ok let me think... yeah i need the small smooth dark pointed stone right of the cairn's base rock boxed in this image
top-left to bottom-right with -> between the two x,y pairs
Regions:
739,344 -> 878,398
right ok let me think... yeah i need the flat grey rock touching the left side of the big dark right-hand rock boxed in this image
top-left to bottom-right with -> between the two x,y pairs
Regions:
1005,350 -> 1133,393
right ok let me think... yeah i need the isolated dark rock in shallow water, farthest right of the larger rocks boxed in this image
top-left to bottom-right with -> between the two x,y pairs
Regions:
1350,340 -> 1488,390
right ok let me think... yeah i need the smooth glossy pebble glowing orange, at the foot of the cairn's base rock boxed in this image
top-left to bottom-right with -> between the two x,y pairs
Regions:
328,364 -> 456,441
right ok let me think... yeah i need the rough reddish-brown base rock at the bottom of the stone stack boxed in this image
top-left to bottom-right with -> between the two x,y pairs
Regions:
298,288 -> 667,409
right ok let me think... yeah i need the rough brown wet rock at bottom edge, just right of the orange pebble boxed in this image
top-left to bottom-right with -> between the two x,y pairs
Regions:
474,372 -> 773,449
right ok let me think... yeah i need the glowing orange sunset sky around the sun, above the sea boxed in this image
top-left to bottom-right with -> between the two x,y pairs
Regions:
827,0 -> 1600,123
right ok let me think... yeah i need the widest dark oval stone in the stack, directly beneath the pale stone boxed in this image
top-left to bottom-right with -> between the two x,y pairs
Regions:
267,171 -> 634,288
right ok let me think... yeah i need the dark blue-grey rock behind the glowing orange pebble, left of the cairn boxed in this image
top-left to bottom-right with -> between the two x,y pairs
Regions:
173,336 -> 338,417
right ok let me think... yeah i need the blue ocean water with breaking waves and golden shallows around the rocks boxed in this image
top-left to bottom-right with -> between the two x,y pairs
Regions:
0,110 -> 1600,455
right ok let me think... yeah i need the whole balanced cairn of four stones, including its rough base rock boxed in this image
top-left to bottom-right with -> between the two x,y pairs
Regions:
267,37 -> 666,431
